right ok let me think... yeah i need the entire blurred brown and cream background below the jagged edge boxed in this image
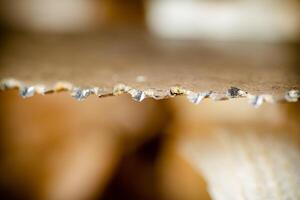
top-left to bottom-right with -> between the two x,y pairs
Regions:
0,91 -> 300,200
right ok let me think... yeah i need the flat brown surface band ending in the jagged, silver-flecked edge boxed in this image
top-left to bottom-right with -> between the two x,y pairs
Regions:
0,31 -> 300,99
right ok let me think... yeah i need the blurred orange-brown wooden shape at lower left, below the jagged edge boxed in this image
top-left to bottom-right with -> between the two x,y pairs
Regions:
0,91 -> 164,200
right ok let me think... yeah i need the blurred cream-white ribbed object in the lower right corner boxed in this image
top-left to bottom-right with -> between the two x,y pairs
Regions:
181,125 -> 300,200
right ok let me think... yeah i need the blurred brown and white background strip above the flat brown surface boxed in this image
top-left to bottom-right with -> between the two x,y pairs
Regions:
1,0 -> 300,42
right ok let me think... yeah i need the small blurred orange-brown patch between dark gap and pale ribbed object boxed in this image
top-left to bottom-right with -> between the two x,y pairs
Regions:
156,136 -> 210,200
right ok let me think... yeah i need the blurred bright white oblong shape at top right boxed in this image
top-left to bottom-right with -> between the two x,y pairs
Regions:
147,0 -> 300,42
